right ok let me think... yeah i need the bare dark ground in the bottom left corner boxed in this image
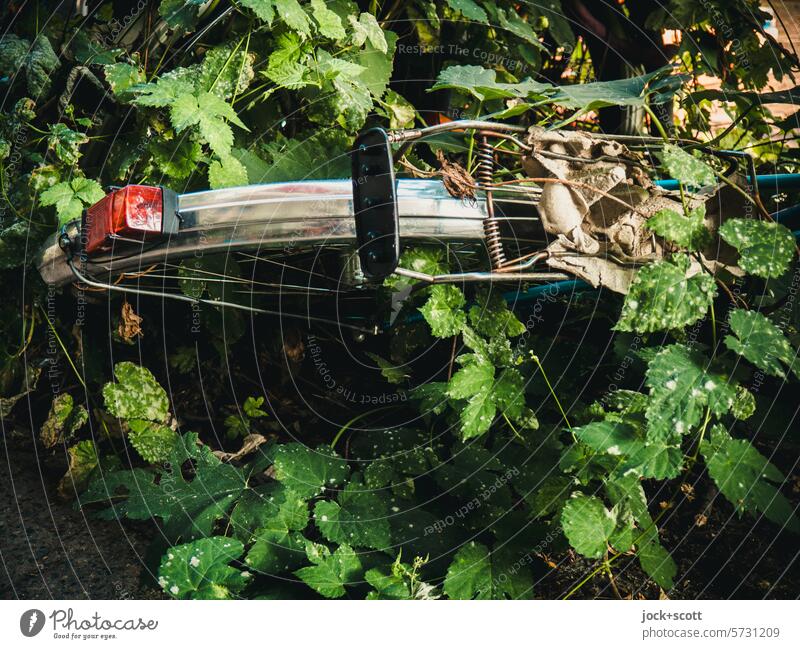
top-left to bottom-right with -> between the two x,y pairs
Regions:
0,431 -> 160,599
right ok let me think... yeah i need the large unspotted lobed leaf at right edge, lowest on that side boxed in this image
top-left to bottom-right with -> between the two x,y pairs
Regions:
700,424 -> 800,533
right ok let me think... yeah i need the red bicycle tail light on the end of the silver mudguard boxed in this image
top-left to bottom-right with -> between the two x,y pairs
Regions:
83,185 -> 164,253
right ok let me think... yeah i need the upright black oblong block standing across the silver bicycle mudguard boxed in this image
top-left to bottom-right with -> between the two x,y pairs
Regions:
352,128 -> 400,280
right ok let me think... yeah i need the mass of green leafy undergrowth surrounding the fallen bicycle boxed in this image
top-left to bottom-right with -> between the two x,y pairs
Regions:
0,0 -> 800,599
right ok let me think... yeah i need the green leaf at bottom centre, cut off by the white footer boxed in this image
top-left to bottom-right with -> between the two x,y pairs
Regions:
444,541 -> 532,599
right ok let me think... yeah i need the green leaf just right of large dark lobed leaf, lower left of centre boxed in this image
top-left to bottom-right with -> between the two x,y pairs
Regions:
275,442 -> 350,498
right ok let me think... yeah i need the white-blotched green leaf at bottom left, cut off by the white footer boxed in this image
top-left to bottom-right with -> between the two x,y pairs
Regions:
158,536 -> 250,599
